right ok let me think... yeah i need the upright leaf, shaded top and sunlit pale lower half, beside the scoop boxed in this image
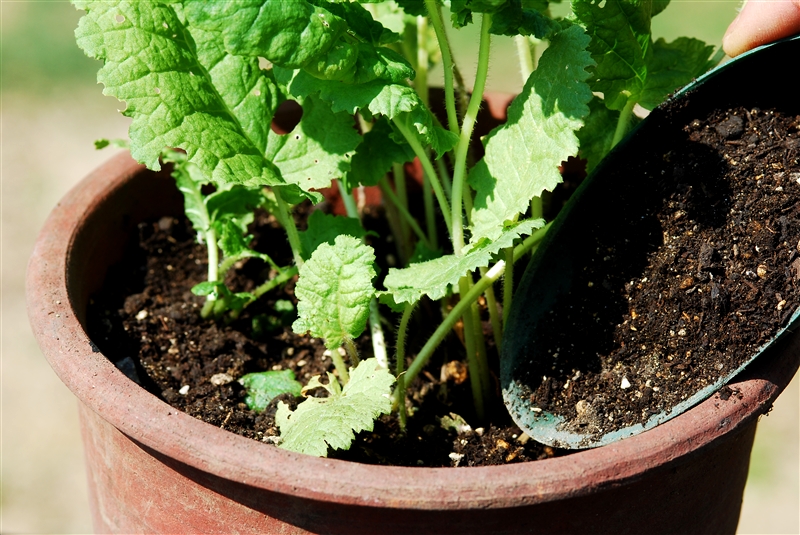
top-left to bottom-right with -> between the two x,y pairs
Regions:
469,25 -> 592,240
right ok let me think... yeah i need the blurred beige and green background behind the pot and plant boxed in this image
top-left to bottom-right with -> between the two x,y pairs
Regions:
0,0 -> 800,534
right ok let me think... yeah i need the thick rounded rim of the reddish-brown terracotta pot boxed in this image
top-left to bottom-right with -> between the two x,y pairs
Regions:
27,153 -> 800,510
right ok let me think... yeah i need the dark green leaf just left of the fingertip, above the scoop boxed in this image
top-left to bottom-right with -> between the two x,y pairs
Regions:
639,37 -> 714,110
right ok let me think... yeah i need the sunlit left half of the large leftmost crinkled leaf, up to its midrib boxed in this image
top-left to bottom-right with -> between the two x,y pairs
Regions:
75,0 -> 283,186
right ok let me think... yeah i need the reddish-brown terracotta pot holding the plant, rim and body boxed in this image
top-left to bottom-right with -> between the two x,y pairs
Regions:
27,155 -> 800,534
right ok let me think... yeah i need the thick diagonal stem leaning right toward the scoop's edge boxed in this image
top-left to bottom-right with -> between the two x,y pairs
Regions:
403,223 -> 551,386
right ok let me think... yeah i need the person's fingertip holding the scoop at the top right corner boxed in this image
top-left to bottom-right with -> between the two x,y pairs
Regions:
722,0 -> 800,57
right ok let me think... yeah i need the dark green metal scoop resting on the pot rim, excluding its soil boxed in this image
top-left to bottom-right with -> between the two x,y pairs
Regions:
500,36 -> 800,449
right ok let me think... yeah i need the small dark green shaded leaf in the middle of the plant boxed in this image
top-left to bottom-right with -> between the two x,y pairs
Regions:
345,118 -> 414,191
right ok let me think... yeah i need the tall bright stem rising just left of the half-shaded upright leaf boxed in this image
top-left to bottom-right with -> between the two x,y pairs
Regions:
450,13 -> 492,256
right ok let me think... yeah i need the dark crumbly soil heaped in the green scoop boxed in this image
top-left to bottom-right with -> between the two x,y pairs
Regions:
520,108 -> 800,442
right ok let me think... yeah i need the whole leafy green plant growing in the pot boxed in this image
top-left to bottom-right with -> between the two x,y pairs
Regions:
73,0 -> 715,455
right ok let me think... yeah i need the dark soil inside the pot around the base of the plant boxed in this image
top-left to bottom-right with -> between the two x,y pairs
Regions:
88,198 -> 559,466
